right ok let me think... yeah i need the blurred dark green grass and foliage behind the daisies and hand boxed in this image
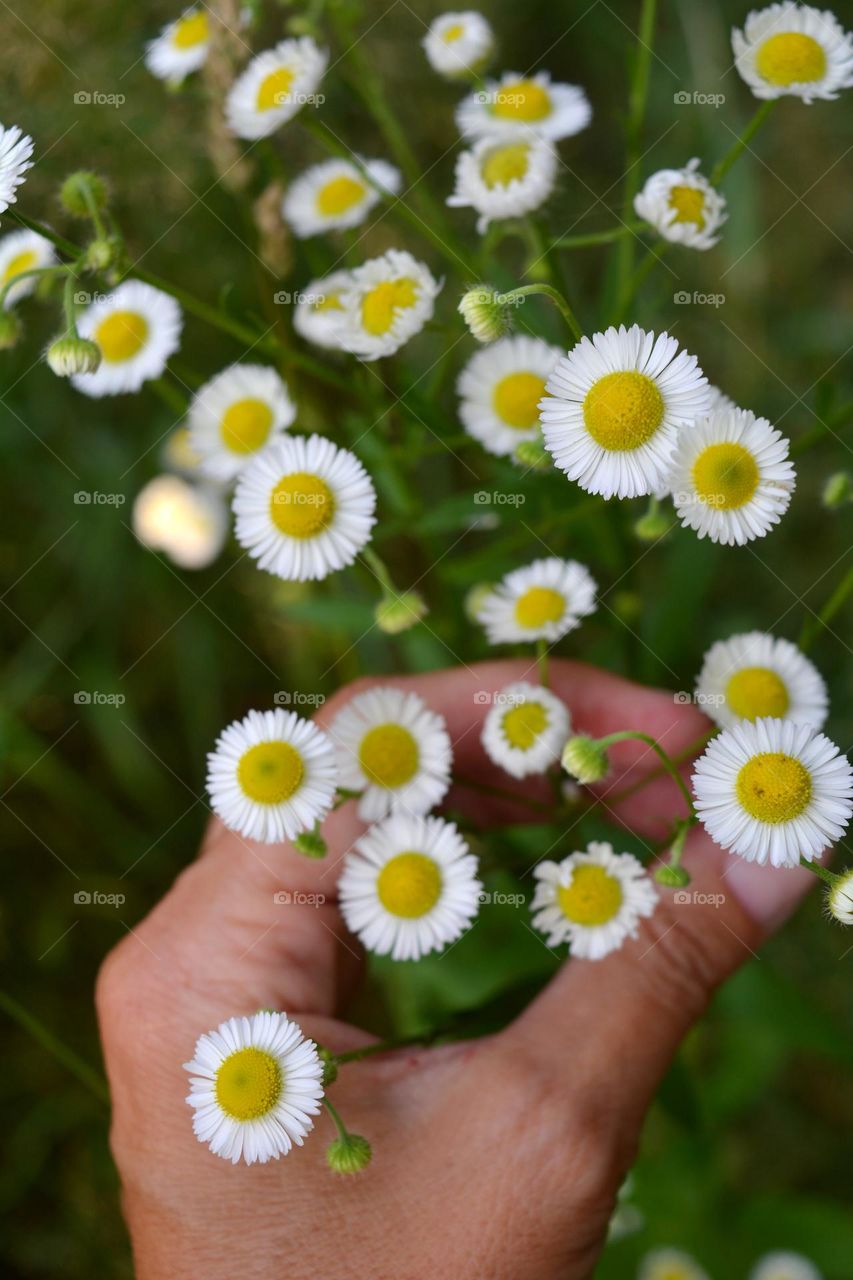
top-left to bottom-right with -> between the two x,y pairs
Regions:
0,0 -> 853,1280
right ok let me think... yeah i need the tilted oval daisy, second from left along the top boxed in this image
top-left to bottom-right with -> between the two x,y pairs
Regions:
225,36 -> 329,140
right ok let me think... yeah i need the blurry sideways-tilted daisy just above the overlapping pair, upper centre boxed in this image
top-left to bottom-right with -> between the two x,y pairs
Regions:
282,160 -> 402,239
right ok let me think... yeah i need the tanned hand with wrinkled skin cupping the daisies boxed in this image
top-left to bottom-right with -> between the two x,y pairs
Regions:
97,660 -> 811,1280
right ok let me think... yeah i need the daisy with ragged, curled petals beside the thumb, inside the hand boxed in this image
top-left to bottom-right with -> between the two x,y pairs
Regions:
530,841 -> 657,960
